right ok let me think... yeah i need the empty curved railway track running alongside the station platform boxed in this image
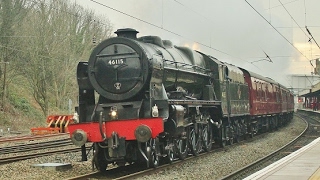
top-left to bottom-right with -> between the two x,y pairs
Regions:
222,113 -> 320,180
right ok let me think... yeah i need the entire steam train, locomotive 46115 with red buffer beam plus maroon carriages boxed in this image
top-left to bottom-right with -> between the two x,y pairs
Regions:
68,28 -> 294,171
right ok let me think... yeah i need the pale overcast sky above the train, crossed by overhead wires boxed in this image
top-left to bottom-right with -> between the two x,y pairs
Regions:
74,0 -> 320,86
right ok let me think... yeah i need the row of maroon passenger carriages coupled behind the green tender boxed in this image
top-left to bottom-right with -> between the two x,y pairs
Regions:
242,69 -> 293,132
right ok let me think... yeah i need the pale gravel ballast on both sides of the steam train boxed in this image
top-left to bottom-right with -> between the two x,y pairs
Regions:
0,114 -> 305,180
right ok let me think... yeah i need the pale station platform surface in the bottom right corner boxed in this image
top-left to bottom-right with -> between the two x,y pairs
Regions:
245,138 -> 320,180
